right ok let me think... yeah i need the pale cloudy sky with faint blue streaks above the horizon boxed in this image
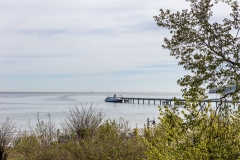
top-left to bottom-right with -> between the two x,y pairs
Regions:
0,0 -> 232,92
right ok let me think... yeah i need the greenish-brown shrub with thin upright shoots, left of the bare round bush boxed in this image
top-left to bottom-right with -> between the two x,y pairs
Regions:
13,113 -> 69,160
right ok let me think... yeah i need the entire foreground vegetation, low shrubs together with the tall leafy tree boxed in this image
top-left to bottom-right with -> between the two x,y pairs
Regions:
0,0 -> 240,160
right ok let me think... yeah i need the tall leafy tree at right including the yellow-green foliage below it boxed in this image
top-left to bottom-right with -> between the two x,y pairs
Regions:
143,0 -> 240,159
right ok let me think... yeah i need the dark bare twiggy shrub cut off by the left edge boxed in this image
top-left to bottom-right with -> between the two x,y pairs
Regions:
0,117 -> 15,160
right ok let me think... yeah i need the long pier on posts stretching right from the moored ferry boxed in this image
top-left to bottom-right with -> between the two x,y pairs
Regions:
120,97 -> 240,108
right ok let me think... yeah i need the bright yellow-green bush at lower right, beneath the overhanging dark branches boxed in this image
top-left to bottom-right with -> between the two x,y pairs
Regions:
142,103 -> 240,159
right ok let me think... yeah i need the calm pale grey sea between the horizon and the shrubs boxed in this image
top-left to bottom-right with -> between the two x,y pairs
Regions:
0,92 -> 218,130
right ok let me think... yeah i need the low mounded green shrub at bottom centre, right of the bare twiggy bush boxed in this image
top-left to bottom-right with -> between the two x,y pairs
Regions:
62,120 -> 145,160
